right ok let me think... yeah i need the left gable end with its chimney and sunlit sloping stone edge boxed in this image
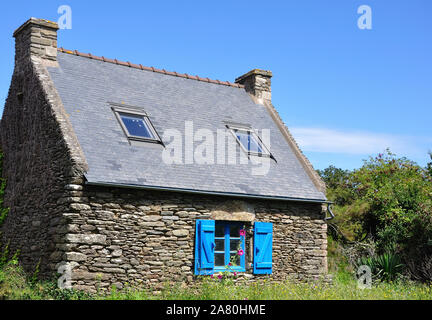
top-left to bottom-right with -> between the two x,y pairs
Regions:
0,18 -> 87,277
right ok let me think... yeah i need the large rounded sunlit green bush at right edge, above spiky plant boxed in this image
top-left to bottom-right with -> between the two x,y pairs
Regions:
350,151 -> 432,252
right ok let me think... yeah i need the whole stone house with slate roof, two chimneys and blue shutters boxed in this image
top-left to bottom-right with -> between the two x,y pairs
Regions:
0,18 -> 328,291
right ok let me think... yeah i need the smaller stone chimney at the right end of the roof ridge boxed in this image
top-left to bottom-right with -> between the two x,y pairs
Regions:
235,69 -> 273,105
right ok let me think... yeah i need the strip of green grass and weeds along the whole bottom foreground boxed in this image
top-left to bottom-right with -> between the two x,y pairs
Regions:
0,264 -> 432,300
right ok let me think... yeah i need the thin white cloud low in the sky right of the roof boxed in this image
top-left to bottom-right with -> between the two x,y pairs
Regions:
290,127 -> 419,155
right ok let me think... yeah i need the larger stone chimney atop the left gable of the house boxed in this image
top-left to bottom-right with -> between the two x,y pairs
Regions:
13,18 -> 59,66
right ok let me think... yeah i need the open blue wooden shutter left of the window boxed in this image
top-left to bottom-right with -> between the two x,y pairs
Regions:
195,220 -> 215,275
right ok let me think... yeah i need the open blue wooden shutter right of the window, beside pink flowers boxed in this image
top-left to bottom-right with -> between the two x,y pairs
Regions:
253,222 -> 273,274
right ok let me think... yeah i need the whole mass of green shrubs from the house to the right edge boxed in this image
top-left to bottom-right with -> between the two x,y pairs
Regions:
318,150 -> 432,281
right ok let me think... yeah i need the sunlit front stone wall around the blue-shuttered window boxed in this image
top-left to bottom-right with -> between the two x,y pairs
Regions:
63,185 -> 327,291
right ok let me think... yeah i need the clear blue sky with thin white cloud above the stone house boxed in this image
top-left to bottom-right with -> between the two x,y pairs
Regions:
0,0 -> 432,169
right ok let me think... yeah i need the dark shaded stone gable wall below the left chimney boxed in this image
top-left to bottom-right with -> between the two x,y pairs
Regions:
0,58 -> 81,274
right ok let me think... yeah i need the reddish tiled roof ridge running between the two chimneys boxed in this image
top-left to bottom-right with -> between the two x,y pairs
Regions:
57,47 -> 244,88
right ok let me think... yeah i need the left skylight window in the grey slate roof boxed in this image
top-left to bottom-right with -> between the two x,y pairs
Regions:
112,105 -> 161,143
